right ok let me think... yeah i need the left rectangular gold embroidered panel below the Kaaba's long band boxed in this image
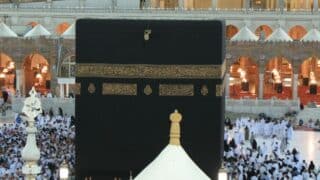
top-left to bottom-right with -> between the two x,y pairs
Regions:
102,83 -> 138,96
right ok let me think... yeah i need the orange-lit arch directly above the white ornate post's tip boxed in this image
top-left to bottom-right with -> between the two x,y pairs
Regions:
22,53 -> 51,94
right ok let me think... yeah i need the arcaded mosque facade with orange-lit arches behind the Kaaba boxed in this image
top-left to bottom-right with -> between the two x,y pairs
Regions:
0,0 -> 320,104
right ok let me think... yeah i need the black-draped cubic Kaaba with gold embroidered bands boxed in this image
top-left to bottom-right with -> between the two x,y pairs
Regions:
76,19 -> 225,180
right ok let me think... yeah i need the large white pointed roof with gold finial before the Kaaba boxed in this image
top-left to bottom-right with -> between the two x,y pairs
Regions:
134,110 -> 210,180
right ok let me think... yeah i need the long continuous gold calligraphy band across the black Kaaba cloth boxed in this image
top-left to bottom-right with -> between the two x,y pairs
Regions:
76,63 -> 222,79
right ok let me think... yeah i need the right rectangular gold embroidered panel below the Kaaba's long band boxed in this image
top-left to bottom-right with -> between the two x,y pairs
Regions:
159,84 -> 194,96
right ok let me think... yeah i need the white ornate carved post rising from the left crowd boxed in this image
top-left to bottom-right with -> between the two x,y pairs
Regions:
21,87 -> 42,180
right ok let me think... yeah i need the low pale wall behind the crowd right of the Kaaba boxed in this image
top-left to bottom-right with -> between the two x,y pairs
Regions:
226,99 -> 300,117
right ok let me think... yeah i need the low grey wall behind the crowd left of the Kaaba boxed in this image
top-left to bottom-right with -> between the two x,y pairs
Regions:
12,98 -> 75,115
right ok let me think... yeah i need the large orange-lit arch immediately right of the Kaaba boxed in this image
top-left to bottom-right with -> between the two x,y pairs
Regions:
229,56 -> 259,99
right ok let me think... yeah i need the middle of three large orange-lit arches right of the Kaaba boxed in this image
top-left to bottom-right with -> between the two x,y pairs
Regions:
263,56 -> 293,99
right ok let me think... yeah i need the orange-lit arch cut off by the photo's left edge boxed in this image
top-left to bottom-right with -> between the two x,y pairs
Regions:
0,53 -> 16,93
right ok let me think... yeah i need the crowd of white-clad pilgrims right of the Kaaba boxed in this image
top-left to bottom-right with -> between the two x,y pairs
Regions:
224,116 -> 320,180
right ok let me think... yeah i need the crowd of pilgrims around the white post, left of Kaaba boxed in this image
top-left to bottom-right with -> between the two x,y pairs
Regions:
0,108 -> 75,180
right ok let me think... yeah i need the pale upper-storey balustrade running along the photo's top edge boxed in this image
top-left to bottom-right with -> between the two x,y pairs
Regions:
0,4 -> 318,15
